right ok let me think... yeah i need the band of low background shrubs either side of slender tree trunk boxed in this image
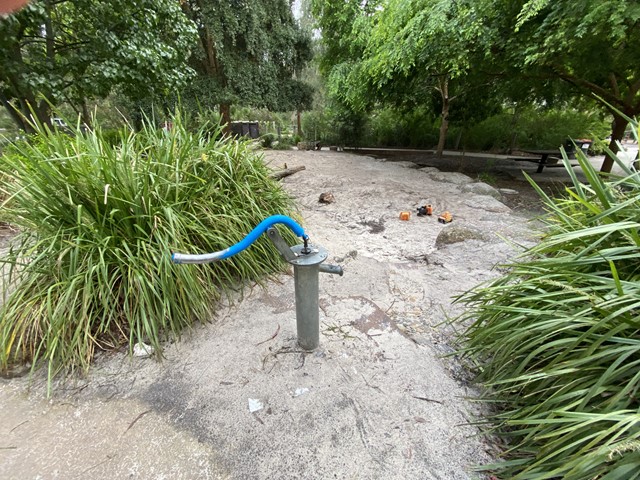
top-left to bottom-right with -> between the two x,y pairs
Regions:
303,106 -> 608,152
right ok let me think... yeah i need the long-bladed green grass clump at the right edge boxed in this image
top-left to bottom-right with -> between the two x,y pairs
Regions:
459,133 -> 640,480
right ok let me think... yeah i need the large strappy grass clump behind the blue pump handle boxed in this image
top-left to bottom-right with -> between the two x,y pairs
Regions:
0,115 -> 292,378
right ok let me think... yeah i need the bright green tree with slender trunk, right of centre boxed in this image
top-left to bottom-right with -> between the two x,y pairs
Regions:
316,0 -> 487,154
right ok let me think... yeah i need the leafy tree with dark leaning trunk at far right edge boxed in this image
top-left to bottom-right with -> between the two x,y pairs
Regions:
477,0 -> 640,172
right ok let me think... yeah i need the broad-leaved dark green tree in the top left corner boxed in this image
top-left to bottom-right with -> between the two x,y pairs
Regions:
0,0 -> 196,130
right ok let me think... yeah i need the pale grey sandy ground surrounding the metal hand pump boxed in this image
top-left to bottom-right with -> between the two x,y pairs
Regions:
0,151 -> 556,480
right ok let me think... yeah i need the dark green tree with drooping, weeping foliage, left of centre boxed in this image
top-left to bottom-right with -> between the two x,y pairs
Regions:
182,0 -> 312,124
